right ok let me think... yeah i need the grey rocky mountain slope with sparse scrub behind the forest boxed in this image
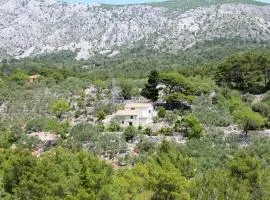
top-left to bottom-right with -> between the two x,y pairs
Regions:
0,0 -> 270,59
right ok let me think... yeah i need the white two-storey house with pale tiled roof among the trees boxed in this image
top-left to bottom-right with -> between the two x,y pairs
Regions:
115,103 -> 154,126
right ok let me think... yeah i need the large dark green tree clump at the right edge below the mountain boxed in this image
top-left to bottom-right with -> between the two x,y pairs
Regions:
216,53 -> 270,94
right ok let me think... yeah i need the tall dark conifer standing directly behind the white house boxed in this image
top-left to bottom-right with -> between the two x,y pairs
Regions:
141,70 -> 159,102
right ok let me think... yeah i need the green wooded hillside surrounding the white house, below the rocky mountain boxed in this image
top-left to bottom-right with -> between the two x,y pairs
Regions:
0,44 -> 270,200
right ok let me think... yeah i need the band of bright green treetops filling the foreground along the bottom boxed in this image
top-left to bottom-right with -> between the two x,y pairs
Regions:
0,135 -> 270,199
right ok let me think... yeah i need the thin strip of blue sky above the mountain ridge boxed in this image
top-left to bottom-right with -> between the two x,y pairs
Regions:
60,0 -> 270,4
